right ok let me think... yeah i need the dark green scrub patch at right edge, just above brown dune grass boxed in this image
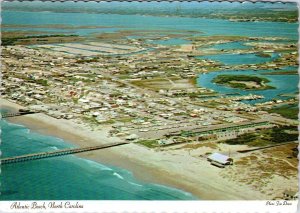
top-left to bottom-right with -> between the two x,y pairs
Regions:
225,126 -> 298,146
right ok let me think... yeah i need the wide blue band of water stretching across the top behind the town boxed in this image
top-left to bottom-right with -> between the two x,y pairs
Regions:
2,6 -> 298,39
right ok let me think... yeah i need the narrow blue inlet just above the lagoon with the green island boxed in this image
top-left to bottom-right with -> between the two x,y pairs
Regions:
196,53 -> 279,65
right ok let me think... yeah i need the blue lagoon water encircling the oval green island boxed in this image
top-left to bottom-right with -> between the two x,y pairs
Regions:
197,70 -> 299,104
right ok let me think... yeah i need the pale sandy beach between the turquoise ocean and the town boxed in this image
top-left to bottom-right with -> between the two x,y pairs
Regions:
0,99 -> 268,200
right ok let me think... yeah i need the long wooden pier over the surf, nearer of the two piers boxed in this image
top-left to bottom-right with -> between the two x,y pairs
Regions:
0,142 -> 128,165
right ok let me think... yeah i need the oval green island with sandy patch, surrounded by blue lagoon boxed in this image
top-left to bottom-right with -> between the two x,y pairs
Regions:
213,75 -> 274,90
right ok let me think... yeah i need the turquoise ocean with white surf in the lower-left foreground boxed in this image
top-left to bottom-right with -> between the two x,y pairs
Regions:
0,120 -> 195,200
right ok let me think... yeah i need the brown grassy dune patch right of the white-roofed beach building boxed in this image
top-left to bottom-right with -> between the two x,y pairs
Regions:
227,144 -> 298,190
